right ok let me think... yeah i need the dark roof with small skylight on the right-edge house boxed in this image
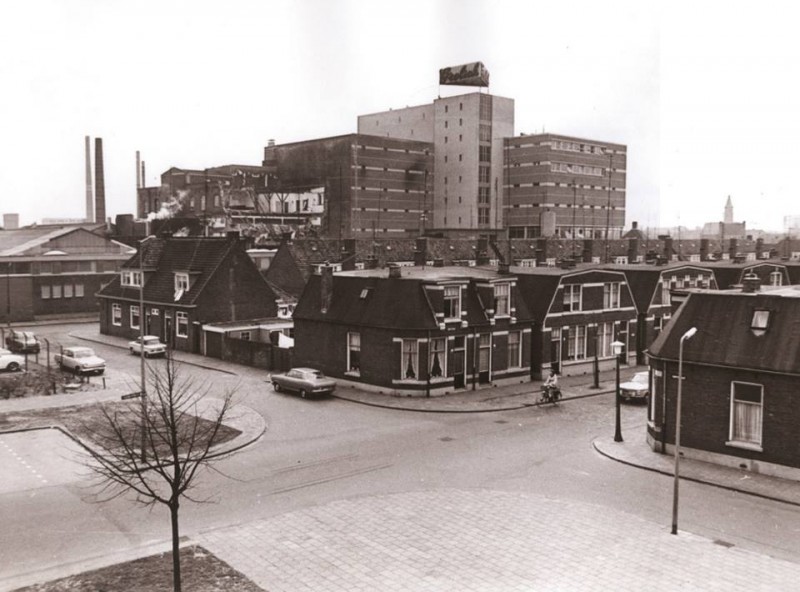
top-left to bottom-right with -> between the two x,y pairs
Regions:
650,287 -> 800,374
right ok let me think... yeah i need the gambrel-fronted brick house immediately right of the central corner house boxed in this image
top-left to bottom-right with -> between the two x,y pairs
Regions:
513,267 -> 636,378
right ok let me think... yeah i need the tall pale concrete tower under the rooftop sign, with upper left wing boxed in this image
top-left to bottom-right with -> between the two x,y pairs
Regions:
358,93 -> 514,230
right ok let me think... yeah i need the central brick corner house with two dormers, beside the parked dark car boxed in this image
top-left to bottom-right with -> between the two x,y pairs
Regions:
294,266 -> 531,396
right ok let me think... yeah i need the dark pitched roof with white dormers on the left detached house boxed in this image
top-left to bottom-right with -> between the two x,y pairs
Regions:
98,238 -> 241,306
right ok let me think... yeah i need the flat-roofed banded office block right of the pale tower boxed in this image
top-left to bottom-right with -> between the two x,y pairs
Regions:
503,134 -> 627,239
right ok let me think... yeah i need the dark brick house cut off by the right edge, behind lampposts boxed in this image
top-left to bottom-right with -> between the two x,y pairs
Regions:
647,276 -> 800,479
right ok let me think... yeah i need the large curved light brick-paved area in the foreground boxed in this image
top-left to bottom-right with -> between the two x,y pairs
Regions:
195,490 -> 800,592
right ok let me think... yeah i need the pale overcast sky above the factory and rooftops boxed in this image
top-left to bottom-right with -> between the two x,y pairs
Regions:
0,0 -> 800,230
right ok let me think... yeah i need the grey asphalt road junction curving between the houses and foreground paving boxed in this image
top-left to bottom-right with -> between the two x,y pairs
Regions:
0,326 -> 800,576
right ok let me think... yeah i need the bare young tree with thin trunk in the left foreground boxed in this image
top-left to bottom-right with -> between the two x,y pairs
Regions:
86,352 -> 233,592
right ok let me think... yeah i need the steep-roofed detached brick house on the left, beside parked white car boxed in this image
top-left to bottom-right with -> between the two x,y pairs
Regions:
98,233 -> 277,352
